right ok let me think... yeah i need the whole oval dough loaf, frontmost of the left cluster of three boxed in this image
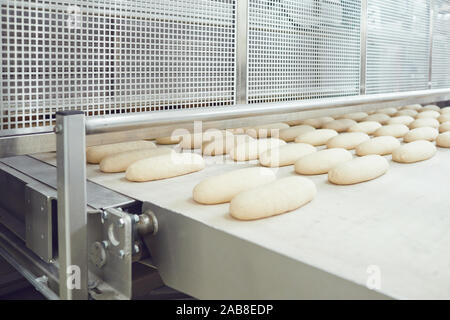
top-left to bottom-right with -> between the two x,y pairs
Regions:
125,152 -> 205,182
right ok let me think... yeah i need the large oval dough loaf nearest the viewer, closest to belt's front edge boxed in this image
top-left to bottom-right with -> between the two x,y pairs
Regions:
230,177 -> 317,220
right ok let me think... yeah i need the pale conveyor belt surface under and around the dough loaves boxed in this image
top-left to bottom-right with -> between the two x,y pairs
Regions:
33,148 -> 450,299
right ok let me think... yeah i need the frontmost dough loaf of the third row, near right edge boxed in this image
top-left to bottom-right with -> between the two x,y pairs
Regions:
392,140 -> 436,163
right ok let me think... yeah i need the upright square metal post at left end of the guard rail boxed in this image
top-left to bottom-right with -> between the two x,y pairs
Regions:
55,111 -> 88,300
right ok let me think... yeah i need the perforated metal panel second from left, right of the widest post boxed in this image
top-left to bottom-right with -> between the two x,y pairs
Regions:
248,0 -> 361,103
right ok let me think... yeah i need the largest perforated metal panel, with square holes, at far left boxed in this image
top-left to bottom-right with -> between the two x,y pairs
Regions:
0,0 -> 235,135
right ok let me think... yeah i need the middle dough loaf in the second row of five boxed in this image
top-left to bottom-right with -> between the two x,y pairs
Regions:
259,143 -> 317,167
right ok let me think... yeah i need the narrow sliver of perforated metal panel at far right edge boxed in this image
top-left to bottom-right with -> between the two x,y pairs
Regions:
431,0 -> 450,88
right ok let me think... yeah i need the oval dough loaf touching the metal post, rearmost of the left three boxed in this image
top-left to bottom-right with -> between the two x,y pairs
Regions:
86,140 -> 156,164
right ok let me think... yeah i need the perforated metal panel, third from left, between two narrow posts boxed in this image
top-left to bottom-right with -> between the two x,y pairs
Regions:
366,0 -> 430,94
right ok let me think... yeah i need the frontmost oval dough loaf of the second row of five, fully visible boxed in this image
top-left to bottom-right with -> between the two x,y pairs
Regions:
328,154 -> 389,185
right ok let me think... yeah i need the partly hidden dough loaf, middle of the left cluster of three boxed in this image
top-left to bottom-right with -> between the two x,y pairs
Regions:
100,147 -> 175,173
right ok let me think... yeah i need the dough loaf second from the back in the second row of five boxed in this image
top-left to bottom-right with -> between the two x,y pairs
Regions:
229,138 -> 286,161
